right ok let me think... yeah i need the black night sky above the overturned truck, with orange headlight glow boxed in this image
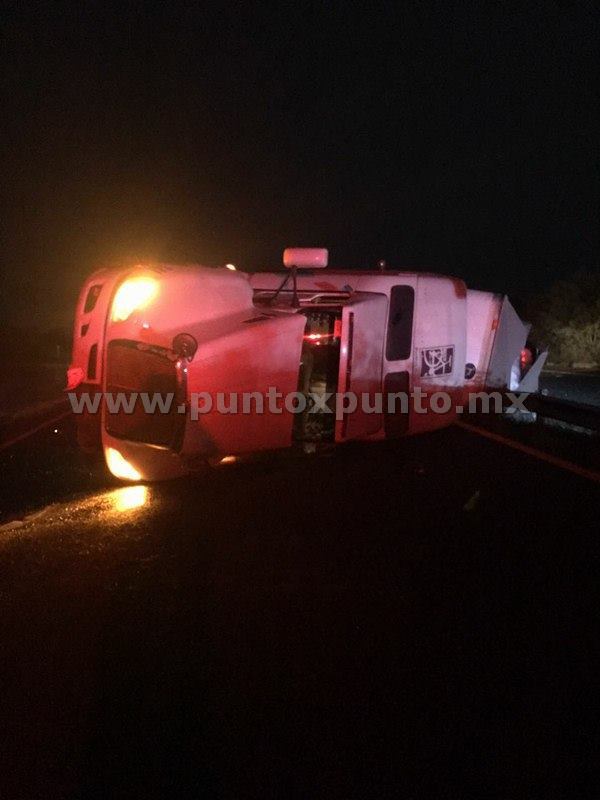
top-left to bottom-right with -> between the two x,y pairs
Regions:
0,2 -> 598,324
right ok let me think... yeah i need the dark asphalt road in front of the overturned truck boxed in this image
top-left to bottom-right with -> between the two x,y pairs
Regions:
0,420 -> 600,800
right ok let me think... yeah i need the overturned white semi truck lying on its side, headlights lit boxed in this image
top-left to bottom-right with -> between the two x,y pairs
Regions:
67,248 -> 545,480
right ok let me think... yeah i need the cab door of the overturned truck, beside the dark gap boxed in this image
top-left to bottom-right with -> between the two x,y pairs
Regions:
335,293 -> 387,442
